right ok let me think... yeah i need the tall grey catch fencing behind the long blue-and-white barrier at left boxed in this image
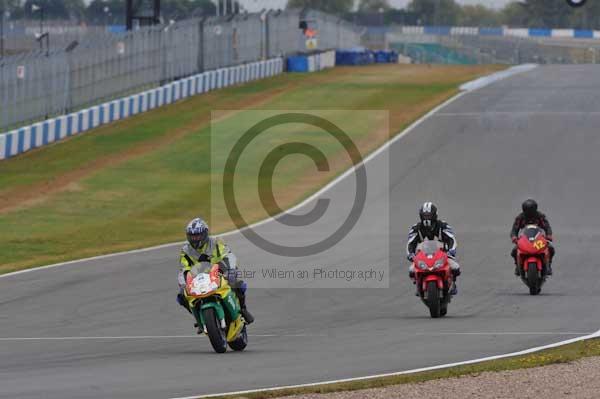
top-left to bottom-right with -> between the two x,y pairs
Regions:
0,10 -> 361,131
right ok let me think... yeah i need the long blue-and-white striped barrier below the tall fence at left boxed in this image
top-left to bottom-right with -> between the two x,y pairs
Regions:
0,58 -> 284,160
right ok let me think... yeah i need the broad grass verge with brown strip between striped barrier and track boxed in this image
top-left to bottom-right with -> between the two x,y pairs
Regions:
0,65 -> 499,273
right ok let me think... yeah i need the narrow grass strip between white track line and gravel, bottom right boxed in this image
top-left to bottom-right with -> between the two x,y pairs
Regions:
207,339 -> 600,399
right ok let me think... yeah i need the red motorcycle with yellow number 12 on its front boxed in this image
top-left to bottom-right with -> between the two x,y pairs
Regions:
517,225 -> 550,295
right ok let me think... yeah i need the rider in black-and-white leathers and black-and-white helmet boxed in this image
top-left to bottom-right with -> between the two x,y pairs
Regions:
406,202 -> 460,295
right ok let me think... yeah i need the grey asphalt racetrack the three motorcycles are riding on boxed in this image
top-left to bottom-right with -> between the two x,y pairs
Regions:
0,66 -> 600,399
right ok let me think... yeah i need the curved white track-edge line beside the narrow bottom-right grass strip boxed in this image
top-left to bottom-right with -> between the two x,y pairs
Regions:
171,331 -> 600,399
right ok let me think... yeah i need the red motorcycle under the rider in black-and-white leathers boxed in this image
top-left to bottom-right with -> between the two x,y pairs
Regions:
413,240 -> 453,318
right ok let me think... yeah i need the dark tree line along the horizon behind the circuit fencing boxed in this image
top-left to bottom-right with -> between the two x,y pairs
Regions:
0,0 -> 600,29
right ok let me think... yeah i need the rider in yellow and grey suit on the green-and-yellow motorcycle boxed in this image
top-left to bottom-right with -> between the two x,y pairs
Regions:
177,218 -> 254,324
